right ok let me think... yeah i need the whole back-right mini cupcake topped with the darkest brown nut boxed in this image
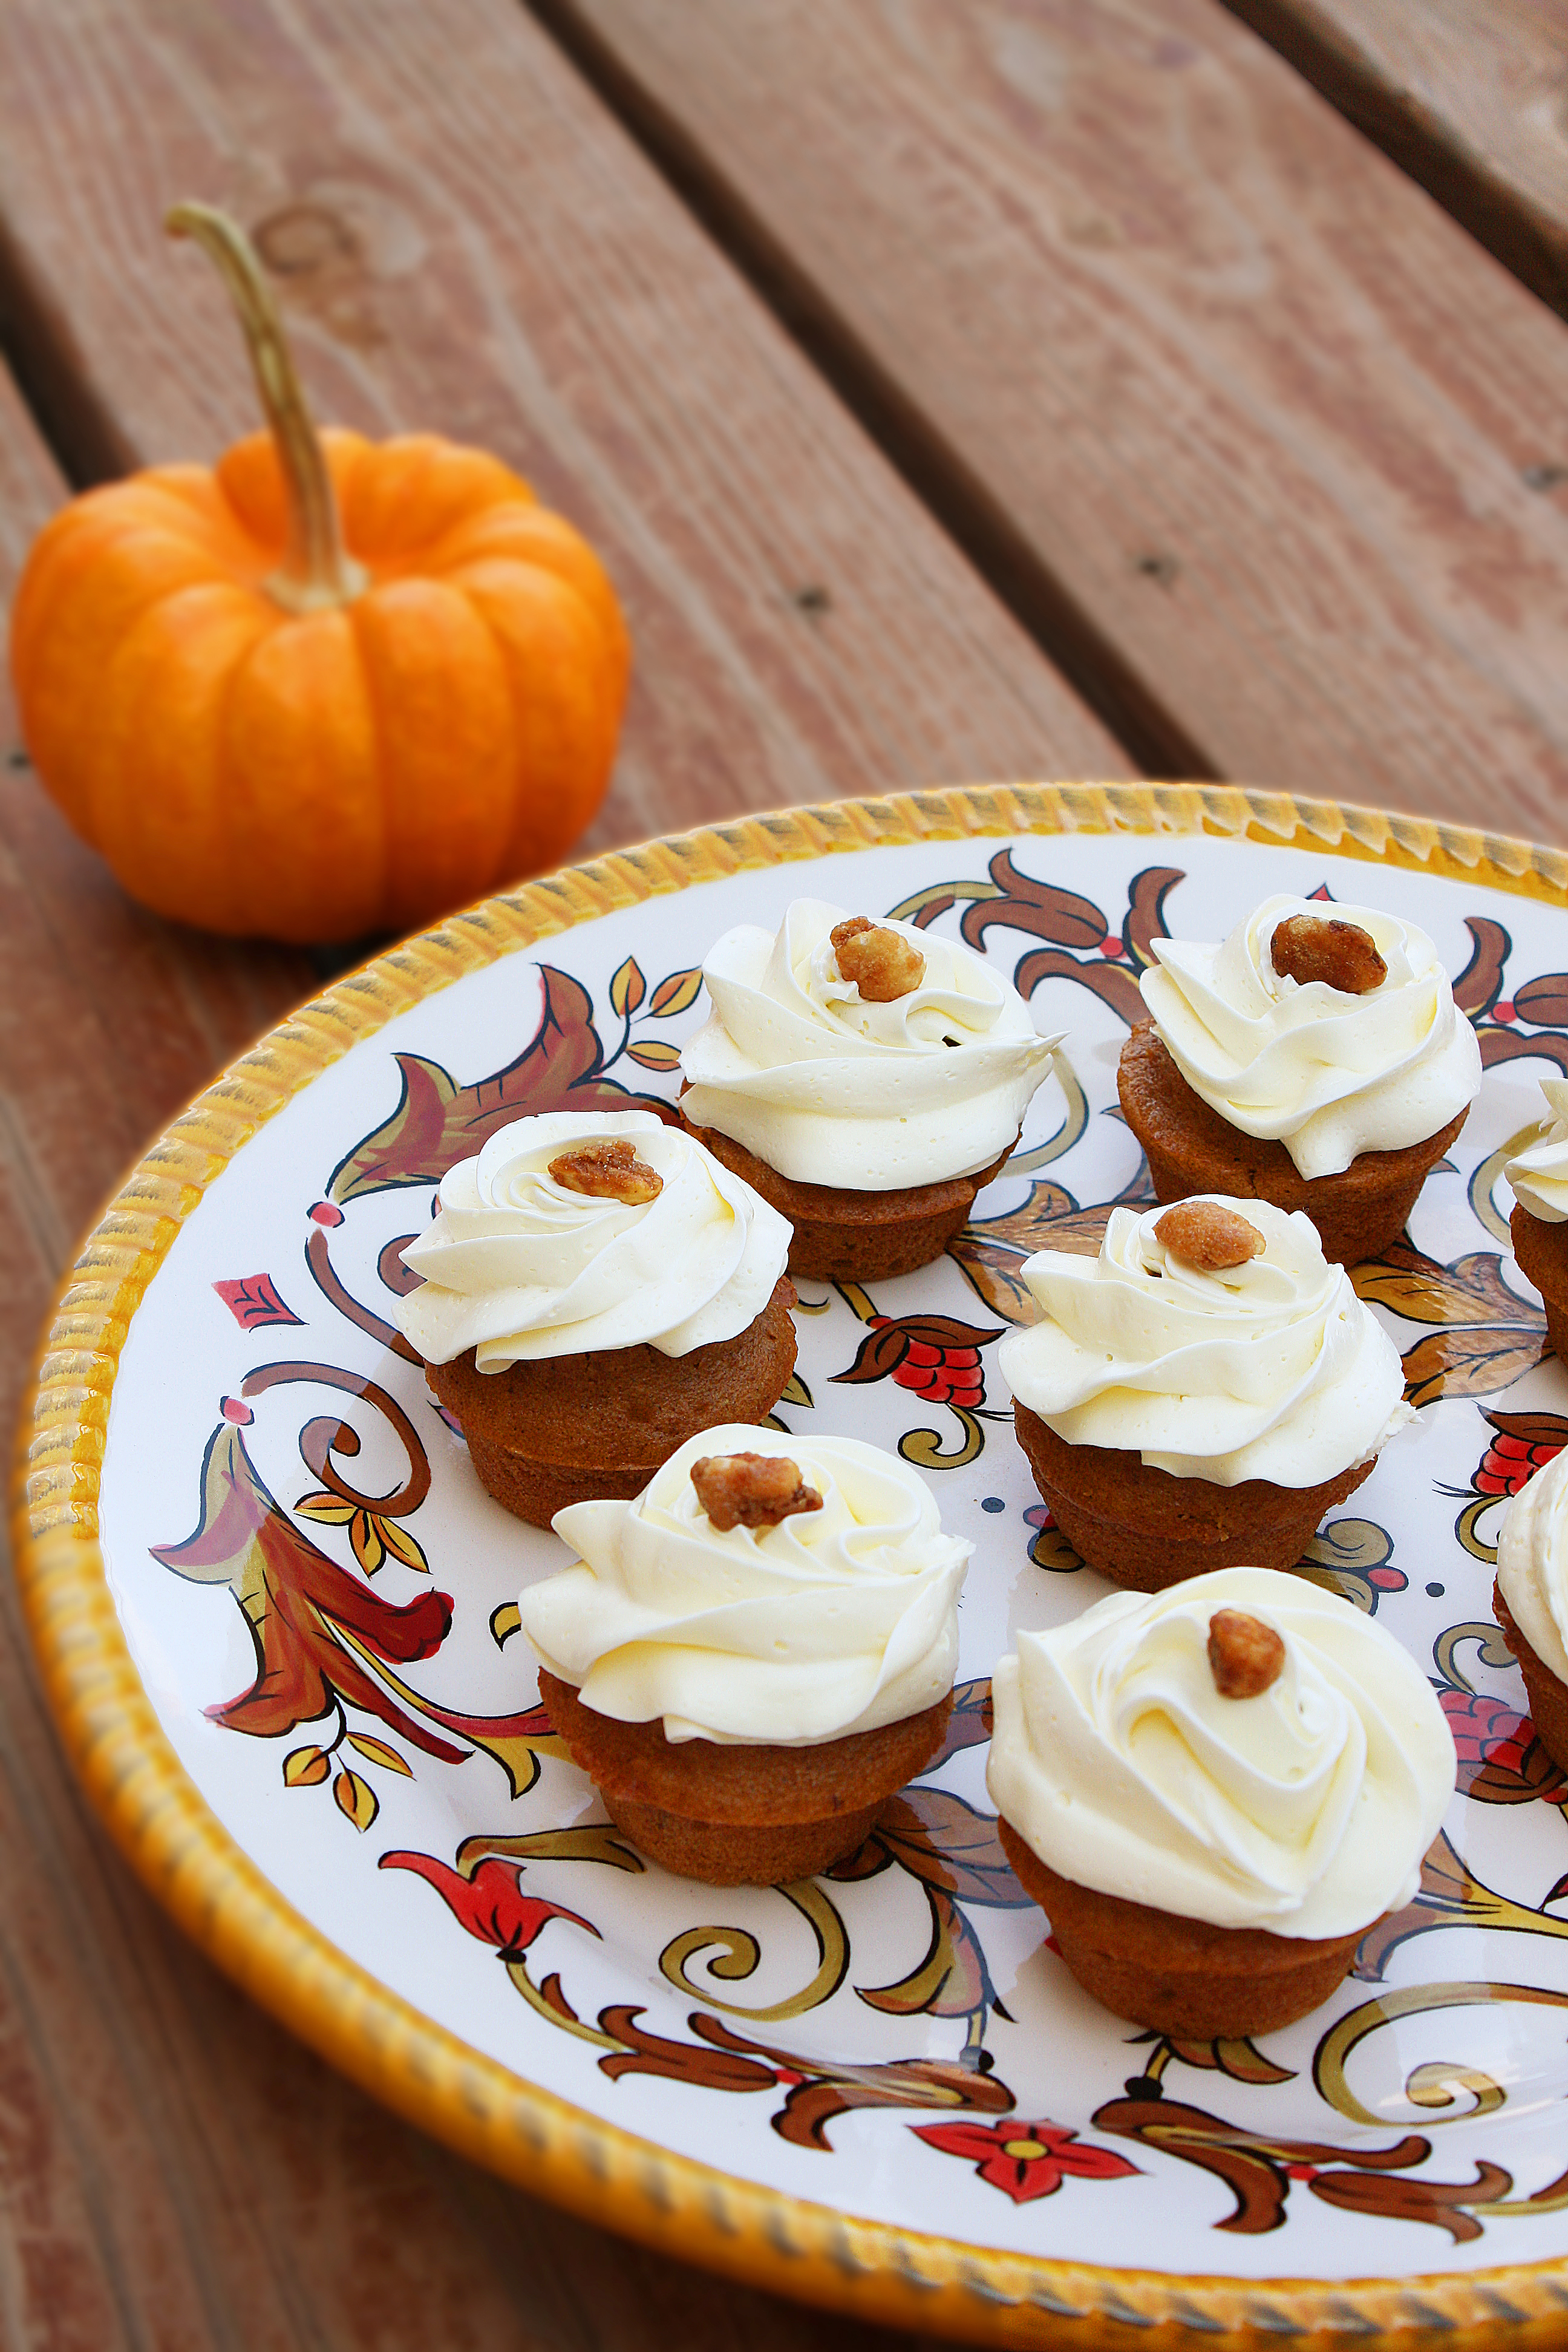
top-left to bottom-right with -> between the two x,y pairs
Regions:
1119,898 -> 1481,1266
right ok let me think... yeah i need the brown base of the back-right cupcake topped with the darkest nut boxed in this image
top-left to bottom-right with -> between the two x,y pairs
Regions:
1117,1021 -> 1469,1266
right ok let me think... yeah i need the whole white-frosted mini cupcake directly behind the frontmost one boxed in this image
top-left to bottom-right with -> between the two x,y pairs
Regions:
997,1195 -> 1413,1592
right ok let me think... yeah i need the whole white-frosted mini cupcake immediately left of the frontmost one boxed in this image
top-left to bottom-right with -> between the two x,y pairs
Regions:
522,1423 -> 973,1886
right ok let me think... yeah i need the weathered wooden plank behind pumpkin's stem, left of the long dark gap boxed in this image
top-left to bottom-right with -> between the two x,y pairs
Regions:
0,0 -> 1131,884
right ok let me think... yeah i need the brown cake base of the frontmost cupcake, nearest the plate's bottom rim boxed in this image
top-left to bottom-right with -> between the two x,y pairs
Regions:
997,1818 -> 1375,2042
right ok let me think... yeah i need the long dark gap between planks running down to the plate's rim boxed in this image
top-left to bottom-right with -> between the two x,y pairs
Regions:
517,0 -> 1225,783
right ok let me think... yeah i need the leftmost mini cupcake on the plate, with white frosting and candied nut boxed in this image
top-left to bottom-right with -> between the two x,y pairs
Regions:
397,1110 -> 794,1526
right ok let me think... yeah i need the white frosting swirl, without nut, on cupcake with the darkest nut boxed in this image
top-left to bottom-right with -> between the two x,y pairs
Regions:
1140,898 -> 1481,1176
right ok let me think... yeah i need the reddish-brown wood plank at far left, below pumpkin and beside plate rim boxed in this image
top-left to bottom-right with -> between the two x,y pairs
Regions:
0,369 -> 940,2352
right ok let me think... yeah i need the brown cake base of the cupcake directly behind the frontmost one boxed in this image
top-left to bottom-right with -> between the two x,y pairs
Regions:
1013,1404 -> 1375,1592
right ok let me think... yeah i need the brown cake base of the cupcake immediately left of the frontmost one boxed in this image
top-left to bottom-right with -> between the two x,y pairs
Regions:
538,1668 -> 952,1886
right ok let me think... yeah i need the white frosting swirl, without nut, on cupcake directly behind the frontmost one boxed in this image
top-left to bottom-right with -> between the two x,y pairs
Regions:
997,1192 -> 1413,1486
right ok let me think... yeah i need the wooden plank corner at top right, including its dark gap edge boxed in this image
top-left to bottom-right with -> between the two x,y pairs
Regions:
1225,0 -> 1568,318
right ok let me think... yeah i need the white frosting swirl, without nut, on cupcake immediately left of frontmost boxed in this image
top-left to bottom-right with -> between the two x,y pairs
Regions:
522,1423 -> 973,1748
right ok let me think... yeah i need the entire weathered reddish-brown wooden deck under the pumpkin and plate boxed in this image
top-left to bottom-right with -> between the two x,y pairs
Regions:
0,0 -> 1568,2352
